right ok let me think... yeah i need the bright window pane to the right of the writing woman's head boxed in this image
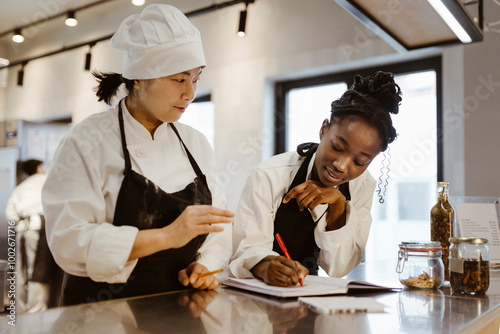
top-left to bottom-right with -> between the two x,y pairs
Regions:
365,71 -> 437,261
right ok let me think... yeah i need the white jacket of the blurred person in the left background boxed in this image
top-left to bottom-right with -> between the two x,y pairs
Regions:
5,174 -> 47,230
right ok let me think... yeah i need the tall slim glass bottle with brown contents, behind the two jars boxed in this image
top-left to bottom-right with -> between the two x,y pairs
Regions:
431,182 -> 455,281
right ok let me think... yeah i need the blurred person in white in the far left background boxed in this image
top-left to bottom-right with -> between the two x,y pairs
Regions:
5,159 -> 48,313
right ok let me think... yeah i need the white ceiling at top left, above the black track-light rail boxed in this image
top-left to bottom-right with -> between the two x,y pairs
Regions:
0,0 -> 227,62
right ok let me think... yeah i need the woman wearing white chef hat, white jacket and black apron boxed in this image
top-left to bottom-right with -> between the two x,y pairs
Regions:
42,5 -> 233,305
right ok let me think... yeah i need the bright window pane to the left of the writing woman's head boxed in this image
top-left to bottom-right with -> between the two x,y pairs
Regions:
285,82 -> 347,152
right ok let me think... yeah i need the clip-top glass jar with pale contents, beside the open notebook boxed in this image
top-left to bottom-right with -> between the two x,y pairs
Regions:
396,241 -> 444,289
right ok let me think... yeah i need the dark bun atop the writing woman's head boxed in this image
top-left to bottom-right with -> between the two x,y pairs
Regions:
351,71 -> 402,114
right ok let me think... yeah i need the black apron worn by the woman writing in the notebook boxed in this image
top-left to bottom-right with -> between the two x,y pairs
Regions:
273,143 -> 351,275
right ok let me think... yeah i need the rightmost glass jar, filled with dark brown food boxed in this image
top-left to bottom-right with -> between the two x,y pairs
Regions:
450,238 -> 490,295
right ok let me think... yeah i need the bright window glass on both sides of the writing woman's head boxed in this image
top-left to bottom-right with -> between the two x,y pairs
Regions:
286,70 -> 437,261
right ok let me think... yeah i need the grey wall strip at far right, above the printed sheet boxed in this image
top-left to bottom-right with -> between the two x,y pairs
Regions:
463,1 -> 500,197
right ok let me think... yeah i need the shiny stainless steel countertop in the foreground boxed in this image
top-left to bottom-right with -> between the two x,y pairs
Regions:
0,261 -> 500,334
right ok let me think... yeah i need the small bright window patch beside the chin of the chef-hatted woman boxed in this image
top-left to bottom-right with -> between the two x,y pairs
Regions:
179,102 -> 215,148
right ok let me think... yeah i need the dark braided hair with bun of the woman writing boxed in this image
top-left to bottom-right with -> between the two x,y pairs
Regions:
330,71 -> 402,152
